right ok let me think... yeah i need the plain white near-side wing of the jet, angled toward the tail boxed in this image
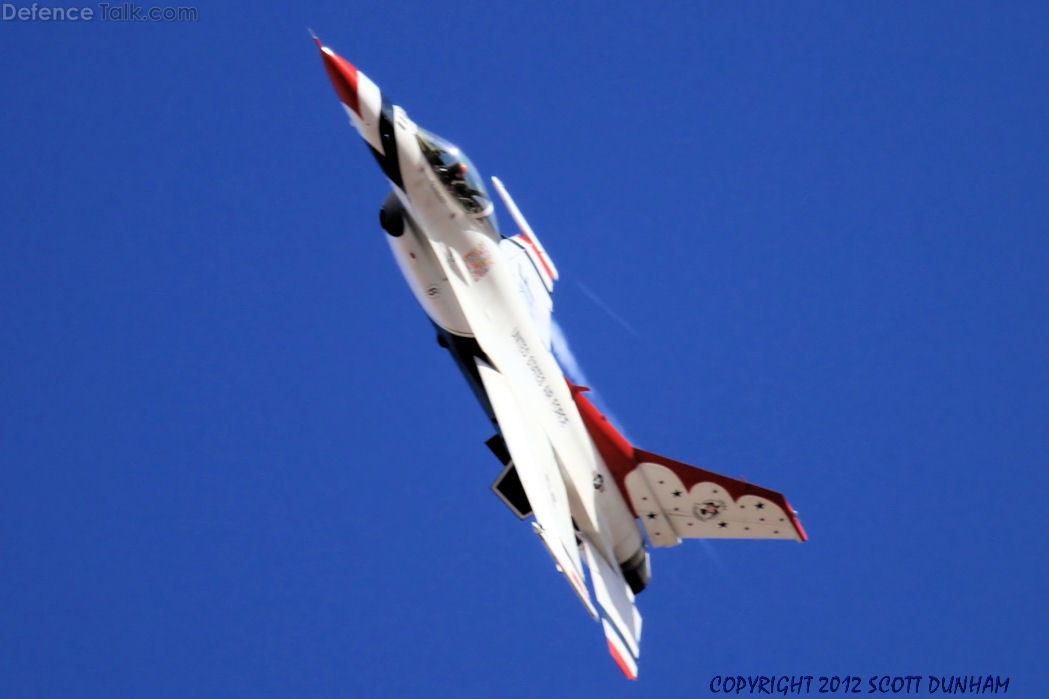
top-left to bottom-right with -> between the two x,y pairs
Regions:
475,359 -> 597,619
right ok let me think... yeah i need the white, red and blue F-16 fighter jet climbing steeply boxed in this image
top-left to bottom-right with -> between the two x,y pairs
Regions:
314,37 -> 806,679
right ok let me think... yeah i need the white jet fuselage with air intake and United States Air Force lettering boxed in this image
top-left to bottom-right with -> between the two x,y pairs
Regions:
347,81 -> 644,563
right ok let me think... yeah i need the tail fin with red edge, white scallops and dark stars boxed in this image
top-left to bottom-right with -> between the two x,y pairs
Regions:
624,449 -> 807,546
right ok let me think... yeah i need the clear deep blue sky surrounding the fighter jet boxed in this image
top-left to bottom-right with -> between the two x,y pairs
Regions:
0,2 -> 1049,697
